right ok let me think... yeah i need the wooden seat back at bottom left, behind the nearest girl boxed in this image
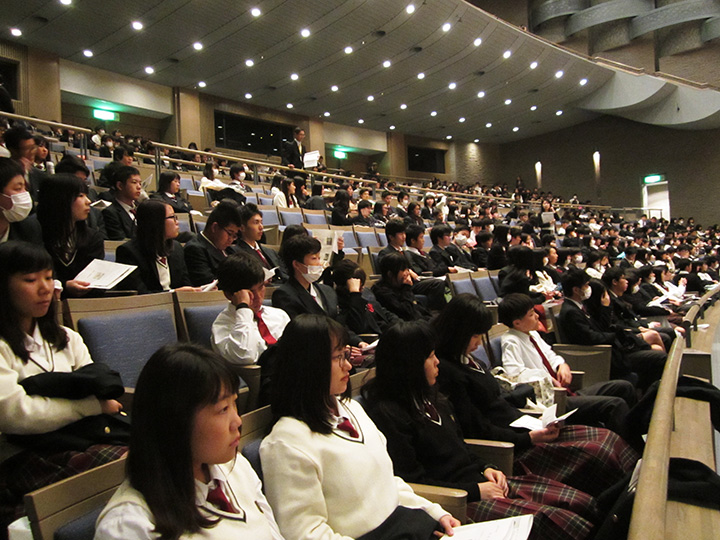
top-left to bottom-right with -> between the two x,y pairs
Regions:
25,457 -> 125,540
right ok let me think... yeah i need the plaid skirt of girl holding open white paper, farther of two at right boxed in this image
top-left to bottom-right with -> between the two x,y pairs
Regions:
514,426 -> 640,496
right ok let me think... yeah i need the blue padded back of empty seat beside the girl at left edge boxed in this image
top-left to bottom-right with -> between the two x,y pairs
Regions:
78,308 -> 177,388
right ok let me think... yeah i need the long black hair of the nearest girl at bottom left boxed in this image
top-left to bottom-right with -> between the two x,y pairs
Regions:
127,343 -> 238,540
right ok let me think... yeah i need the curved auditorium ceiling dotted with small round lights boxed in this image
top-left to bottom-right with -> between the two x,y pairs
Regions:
2,0 -> 720,143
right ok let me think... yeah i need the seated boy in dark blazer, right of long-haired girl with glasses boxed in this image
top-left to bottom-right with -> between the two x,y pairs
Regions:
185,201 -> 242,287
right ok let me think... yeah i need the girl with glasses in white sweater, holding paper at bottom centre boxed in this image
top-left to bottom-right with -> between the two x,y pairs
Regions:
260,315 -> 459,540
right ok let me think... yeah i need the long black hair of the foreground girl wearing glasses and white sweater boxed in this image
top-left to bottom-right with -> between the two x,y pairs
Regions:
272,314 -> 351,434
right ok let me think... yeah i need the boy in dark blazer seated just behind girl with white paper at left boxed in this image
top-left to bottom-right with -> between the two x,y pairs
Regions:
103,165 -> 142,240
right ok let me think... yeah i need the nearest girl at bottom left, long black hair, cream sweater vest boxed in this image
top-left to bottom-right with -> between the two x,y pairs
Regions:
95,344 -> 283,540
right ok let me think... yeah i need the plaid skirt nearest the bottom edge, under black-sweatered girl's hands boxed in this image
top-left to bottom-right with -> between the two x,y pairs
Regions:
468,474 -> 600,540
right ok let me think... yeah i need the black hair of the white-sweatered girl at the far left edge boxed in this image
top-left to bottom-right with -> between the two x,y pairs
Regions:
0,241 -> 68,363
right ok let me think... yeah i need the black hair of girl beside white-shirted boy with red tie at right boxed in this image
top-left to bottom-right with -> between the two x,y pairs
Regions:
433,293 -> 493,364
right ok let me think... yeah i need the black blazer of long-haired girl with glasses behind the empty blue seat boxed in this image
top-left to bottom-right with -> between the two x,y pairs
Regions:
115,239 -> 190,294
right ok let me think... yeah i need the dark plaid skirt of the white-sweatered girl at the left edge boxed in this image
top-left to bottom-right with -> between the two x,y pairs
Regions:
0,444 -> 127,539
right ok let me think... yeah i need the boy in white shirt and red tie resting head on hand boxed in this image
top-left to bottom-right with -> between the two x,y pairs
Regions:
211,252 -> 290,365
